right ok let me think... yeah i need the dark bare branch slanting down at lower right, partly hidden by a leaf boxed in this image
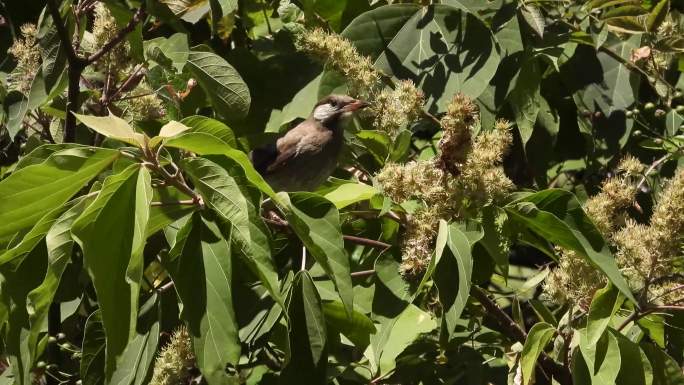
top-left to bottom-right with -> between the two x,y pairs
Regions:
470,286 -> 572,385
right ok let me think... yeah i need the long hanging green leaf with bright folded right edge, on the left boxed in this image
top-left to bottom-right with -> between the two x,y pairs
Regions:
71,164 -> 152,378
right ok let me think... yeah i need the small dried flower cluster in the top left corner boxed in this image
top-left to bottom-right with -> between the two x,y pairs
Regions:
7,24 -> 40,93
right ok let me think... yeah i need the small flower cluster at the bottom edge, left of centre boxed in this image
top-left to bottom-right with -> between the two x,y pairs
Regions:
150,327 -> 195,385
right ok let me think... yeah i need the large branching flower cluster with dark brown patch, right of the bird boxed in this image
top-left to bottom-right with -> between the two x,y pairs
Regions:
377,96 -> 513,279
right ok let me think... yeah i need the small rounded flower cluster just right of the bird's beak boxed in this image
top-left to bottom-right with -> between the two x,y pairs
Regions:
371,80 -> 425,136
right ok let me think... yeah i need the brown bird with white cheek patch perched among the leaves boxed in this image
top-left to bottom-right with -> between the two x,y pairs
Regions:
250,94 -> 369,192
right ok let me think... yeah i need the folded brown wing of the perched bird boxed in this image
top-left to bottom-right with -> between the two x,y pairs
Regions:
266,120 -> 332,173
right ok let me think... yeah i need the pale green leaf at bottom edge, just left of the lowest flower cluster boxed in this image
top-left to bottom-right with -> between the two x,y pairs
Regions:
108,294 -> 161,385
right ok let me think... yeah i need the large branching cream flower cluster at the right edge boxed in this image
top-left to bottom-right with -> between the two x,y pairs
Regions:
544,157 -> 684,307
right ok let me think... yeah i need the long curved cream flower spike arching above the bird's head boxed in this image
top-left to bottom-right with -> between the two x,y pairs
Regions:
295,28 -> 380,97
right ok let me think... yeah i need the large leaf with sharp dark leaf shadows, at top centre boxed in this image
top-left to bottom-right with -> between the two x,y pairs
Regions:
342,4 -> 499,109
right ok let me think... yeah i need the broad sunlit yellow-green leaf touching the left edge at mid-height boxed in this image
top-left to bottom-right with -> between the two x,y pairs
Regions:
0,147 -> 119,239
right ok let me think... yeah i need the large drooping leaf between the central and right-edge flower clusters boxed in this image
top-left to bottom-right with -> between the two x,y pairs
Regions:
505,189 -> 636,303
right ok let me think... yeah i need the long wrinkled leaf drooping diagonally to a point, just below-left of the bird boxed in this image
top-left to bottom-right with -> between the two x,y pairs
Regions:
181,158 -> 285,308
